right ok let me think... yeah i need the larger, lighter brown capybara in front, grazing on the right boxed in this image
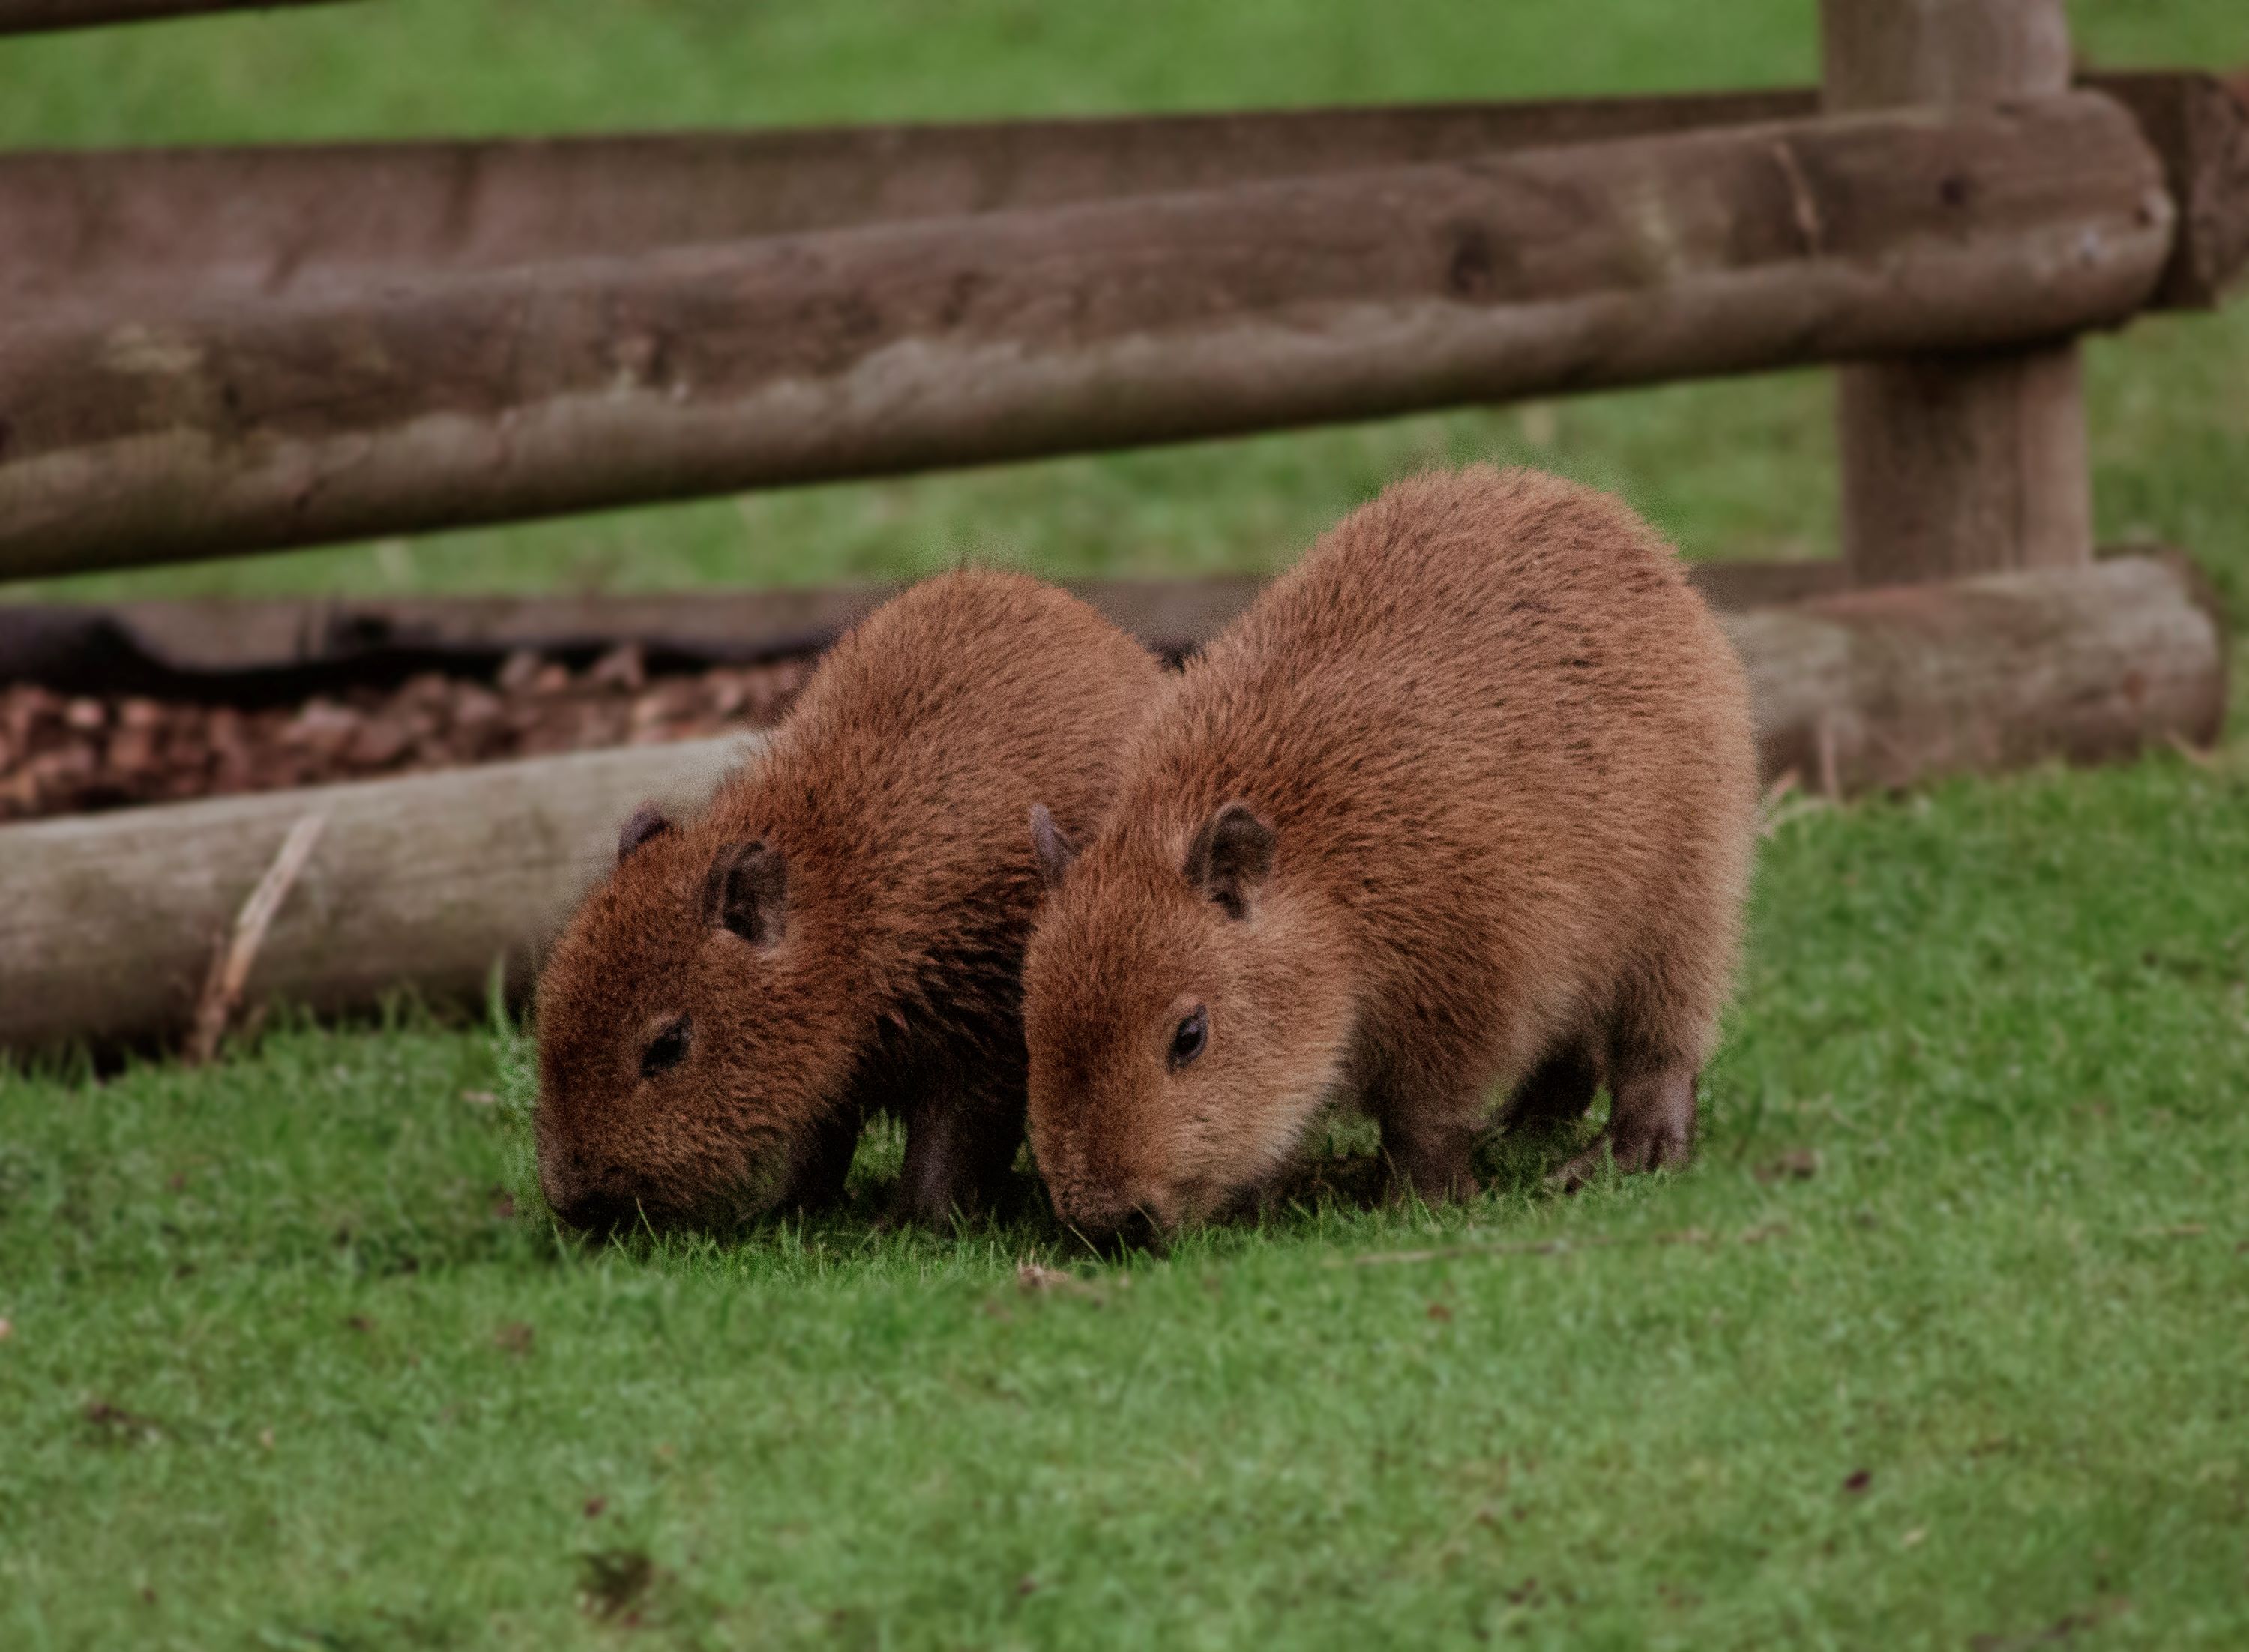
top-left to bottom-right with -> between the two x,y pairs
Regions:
1023,468 -> 1756,1234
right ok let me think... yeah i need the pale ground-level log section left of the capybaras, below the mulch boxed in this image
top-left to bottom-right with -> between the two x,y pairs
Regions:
0,740 -> 753,1047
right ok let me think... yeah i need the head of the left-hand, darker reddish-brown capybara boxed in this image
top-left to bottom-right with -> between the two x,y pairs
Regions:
535,807 -> 852,1229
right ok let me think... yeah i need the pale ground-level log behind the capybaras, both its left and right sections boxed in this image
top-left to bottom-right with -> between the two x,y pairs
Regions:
0,558 -> 2227,1047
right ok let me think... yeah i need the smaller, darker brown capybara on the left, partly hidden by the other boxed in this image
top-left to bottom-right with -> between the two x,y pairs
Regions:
538,573 -> 1163,1227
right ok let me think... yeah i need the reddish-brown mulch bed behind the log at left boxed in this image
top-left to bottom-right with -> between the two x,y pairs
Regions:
0,648 -> 812,821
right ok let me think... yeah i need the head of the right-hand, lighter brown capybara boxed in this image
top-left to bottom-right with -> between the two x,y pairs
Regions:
1023,801 -> 1352,1238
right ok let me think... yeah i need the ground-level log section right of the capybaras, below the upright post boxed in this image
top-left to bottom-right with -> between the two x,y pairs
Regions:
1727,555 -> 2227,792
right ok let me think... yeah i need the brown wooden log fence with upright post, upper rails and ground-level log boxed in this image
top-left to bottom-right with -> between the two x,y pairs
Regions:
0,0 -> 2249,1043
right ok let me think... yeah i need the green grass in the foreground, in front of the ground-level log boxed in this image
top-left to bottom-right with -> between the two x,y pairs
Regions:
0,756 -> 2249,1648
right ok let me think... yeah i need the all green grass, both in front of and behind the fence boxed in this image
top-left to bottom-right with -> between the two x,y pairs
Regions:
0,0 -> 2249,1652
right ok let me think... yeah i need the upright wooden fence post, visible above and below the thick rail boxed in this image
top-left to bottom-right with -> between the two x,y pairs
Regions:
1819,0 -> 2094,585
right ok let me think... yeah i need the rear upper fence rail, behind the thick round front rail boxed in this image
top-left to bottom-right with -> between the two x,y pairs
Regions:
0,72 -> 2249,319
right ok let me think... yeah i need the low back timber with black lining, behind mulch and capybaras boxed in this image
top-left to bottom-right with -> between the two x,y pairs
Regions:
0,560 -> 1846,702
